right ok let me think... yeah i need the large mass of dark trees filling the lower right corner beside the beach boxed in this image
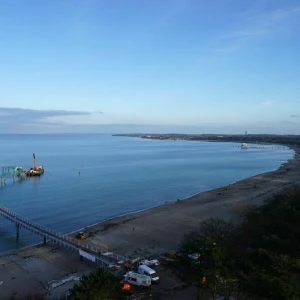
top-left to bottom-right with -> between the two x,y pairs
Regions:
176,189 -> 300,300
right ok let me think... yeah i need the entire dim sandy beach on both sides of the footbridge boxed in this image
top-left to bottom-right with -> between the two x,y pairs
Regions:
0,147 -> 300,299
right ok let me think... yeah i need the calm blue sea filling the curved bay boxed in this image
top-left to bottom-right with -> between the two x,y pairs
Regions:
0,134 -> 294,252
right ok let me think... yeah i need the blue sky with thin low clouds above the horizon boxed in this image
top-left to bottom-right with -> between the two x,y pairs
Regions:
0,0 -> 300,134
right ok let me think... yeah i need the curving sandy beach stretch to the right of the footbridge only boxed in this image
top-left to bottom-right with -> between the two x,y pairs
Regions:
73,146 -> 300,257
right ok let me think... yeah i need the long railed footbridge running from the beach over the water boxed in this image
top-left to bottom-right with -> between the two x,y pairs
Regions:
0,205 -> 126,267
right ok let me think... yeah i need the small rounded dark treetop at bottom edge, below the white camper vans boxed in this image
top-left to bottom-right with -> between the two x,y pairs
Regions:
70,268 -> 125,300
